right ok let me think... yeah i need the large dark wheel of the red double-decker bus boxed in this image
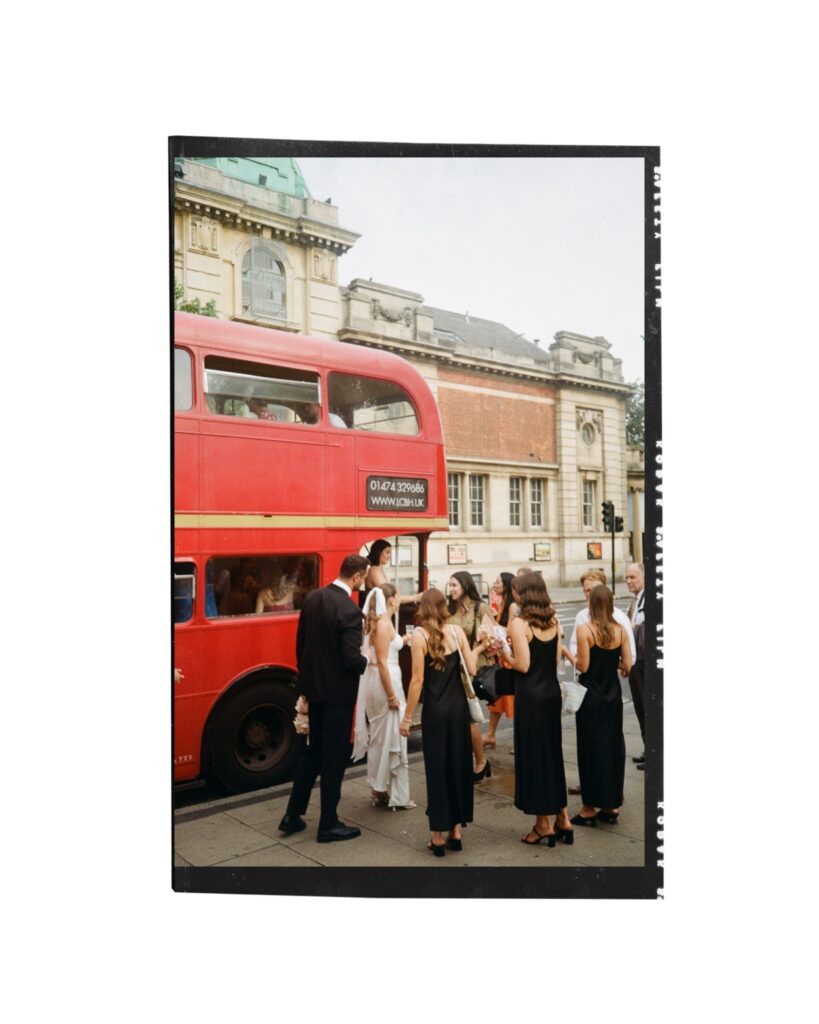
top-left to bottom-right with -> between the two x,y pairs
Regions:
210,681 -> 298,793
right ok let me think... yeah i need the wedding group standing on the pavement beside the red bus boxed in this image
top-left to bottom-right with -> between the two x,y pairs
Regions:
279,542 -> 642,857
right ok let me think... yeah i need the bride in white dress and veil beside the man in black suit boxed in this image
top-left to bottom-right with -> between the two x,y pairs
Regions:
352,583 -> 417,811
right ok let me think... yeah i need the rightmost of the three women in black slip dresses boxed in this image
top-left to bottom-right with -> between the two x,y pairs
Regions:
571,584 -> 632,826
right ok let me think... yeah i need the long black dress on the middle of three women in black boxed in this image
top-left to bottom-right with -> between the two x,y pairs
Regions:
514,633 -> 566,814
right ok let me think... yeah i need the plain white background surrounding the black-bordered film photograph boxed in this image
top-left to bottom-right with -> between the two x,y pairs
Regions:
2,2 -> 817,1021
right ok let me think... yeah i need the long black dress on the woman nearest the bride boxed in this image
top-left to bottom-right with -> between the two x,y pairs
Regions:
421,650 -> 474,831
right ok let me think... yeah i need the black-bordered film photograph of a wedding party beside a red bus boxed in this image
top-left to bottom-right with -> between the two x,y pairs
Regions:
168,136 -> 662,899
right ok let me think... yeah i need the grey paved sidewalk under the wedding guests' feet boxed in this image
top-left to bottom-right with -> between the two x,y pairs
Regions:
174,701 -> 645,867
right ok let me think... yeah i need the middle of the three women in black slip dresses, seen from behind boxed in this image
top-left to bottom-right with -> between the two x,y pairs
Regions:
509,572 -> 574,847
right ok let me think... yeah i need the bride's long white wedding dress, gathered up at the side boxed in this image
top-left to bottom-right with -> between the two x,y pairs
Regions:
352,636 -> 411,807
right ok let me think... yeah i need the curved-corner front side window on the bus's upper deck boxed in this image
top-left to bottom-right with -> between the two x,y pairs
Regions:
330,373 -> 418,434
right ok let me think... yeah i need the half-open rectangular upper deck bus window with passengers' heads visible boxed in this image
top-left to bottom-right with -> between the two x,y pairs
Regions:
205,355 -> 321,425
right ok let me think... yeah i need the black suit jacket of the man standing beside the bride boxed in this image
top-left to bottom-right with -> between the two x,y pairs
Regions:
296,584 -> 368,708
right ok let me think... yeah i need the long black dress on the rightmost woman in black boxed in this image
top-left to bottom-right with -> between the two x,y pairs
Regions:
575,630 -> 626,808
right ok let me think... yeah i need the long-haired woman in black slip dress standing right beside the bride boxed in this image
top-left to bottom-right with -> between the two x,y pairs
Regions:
400,589 -> 487,857
